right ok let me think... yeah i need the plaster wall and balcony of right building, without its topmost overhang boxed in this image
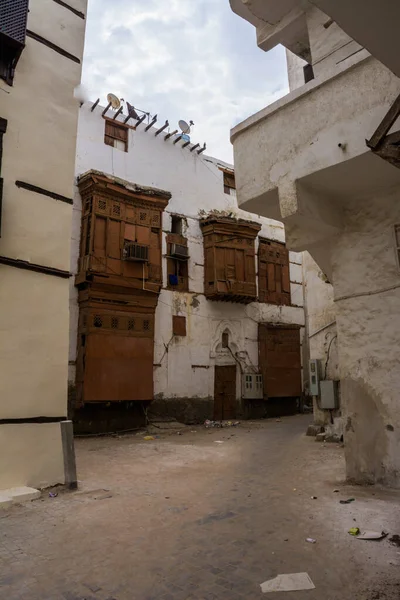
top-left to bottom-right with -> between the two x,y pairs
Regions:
232,0 -> 400,487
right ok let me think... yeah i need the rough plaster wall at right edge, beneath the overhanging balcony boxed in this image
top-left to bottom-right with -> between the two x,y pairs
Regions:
332,187 -> 400,486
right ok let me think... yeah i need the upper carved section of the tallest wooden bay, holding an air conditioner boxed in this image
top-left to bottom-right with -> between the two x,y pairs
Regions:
76,172 -> 170,291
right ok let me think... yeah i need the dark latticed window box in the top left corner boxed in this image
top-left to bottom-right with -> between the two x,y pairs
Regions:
0,0 -> 29,85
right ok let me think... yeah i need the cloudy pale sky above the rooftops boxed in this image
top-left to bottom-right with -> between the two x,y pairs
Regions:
83,0 -> 288,162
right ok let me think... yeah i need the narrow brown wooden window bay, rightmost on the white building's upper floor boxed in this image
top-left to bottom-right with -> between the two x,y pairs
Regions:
258,239 -> 290,306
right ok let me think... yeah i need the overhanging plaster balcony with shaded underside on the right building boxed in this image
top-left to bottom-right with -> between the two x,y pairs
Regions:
231,50 -> 400,276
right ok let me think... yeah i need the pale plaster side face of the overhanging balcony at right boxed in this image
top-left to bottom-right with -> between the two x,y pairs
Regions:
231,51 -> 399,216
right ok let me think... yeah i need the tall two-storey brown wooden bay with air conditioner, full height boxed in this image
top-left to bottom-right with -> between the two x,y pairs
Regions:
75,171 -> 171,406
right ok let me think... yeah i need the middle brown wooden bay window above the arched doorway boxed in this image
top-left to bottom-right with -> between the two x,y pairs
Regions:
200,216 -> 261,303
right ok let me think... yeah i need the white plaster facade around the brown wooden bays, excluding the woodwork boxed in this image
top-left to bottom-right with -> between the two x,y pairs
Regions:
70,104 -> 304,398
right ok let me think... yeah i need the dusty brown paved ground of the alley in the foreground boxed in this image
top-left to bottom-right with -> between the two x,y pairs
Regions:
0,416 -> 400,600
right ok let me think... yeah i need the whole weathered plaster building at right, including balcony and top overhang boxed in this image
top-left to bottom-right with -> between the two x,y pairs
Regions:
230,0 -> 400,487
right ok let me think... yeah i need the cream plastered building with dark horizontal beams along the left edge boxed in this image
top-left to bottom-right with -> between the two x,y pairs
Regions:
0,0 -> 86,489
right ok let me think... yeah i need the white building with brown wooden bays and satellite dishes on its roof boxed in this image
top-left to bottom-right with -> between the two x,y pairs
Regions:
69,104 -> 304,430
